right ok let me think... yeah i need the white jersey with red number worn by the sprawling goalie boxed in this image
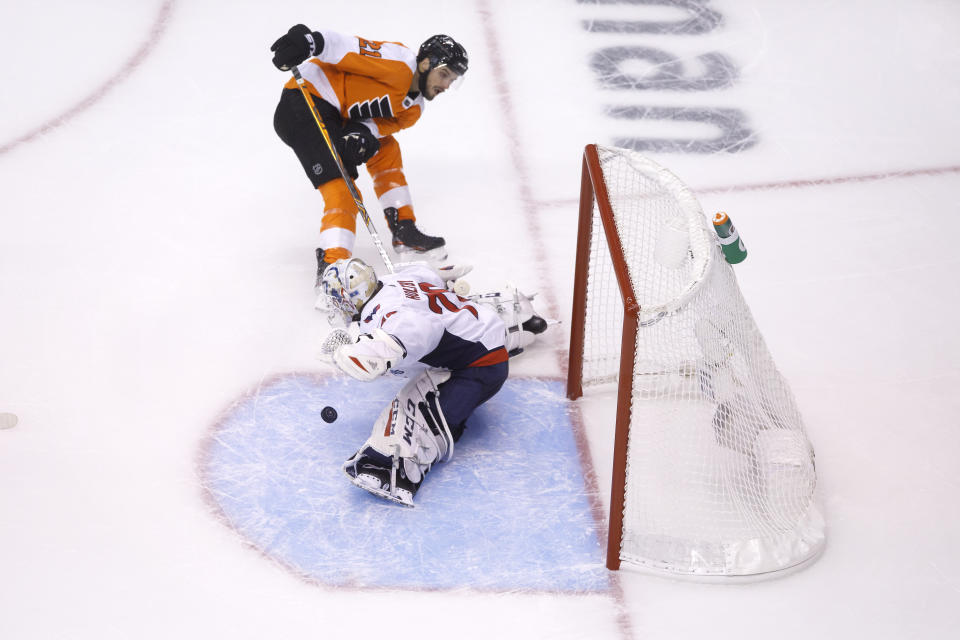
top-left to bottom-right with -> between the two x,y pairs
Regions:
360,265 -> 508,375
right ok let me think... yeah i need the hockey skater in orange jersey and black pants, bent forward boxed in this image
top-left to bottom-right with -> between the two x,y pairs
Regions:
270,24 -> 468,282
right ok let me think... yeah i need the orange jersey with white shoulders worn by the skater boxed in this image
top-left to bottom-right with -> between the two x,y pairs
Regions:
285,31 -> 424,138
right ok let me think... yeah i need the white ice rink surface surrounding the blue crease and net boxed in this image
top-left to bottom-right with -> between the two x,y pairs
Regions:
0,0 -> 960,640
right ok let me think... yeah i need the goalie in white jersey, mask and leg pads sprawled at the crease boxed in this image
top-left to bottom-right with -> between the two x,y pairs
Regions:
321,258 -> 547,506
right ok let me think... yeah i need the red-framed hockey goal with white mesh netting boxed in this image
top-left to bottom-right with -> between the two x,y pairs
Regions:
567,145 -> 824,579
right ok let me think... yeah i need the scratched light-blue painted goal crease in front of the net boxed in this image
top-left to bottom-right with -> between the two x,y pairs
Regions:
202,374 -> 610,593
